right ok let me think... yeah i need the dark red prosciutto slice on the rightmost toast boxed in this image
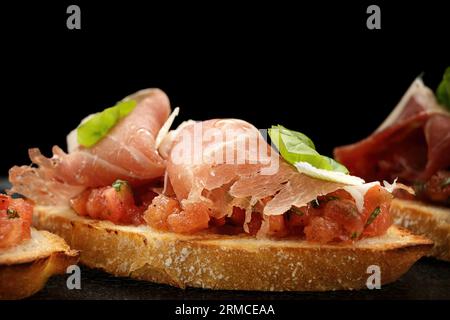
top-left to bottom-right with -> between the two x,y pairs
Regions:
334,79 -> 450,183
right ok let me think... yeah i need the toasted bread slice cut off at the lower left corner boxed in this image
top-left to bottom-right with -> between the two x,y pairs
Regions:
0,228 -> 79,299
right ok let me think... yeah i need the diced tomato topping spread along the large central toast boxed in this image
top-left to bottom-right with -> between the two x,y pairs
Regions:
118,182 -> 392,243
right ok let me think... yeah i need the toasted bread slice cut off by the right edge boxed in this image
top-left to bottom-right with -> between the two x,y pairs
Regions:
391,199 -> 450,261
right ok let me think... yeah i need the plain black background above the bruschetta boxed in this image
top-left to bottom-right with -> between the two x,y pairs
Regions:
0,0 -> 450,175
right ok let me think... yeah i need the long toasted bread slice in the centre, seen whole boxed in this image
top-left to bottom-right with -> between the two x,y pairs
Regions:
34,207 -> 432,291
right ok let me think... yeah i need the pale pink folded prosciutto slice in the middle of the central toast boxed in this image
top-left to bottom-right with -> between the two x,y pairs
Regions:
164,119 -> 343,221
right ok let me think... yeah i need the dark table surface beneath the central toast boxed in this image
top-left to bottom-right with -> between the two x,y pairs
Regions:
0,180 -> 450,300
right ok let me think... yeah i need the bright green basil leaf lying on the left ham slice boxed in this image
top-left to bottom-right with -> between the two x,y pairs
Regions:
77,100 -> 136,148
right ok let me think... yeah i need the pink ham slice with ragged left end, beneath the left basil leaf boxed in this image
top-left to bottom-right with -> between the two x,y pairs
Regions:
10,89 -> 170,204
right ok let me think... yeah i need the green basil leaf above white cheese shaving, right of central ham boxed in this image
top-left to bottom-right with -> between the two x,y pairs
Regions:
269,125 -> 348,174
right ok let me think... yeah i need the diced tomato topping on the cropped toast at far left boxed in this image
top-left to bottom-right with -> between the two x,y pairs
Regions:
0,195 -> 33,248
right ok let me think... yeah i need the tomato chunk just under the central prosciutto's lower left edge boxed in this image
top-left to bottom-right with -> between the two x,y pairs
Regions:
167,203 -> 210,233
